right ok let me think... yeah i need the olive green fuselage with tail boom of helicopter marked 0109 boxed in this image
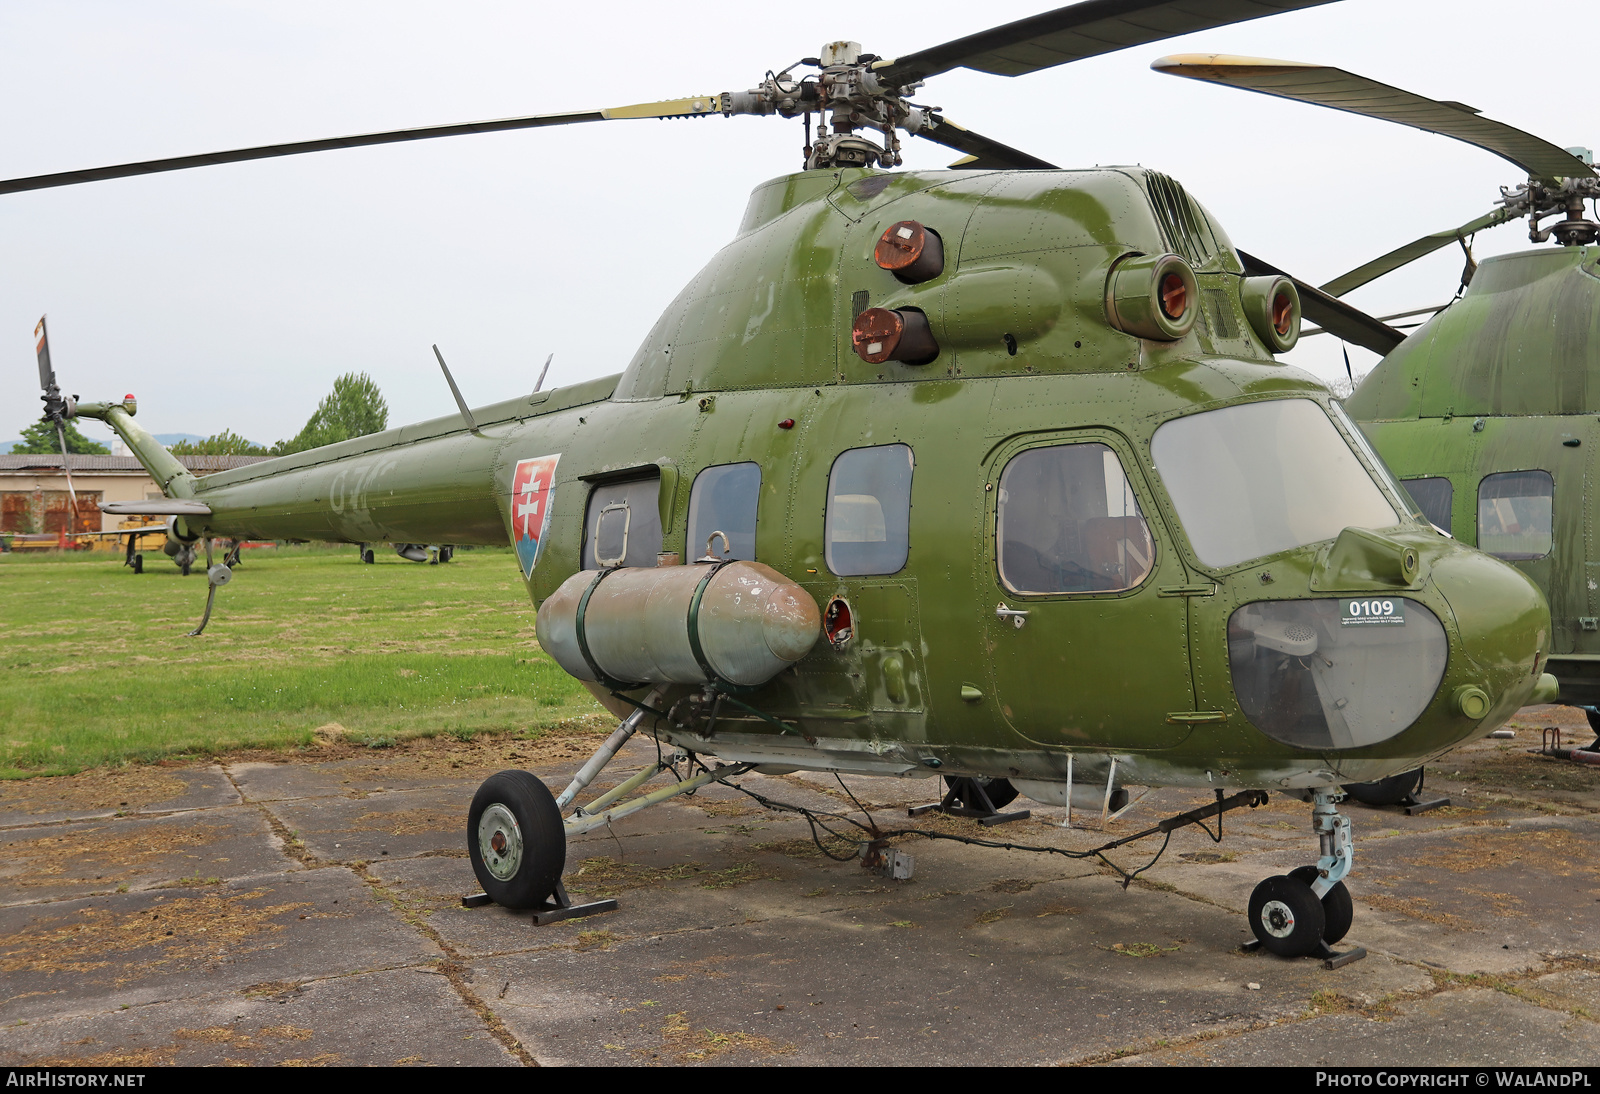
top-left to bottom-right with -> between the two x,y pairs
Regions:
87,170 -> 1549,789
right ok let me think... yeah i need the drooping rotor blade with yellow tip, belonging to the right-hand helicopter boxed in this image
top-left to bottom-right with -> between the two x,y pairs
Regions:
1150,53 -> 1595,184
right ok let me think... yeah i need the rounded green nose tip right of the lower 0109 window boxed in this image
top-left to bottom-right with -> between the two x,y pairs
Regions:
1432,549 -> 1550,725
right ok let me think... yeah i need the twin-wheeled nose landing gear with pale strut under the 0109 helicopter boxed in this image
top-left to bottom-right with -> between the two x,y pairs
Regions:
1245,790 -> 1366,969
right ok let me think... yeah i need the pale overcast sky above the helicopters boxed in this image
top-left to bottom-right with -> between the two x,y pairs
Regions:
0,0 -> 1600,443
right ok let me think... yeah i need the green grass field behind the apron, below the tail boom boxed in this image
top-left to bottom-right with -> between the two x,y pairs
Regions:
0,547 -> 600,779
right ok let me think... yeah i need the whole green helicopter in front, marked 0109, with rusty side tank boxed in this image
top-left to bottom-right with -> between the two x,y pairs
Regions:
15,0 -> 1557,956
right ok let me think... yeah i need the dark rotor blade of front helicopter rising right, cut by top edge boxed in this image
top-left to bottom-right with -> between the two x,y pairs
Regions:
872,0 -> 1331,86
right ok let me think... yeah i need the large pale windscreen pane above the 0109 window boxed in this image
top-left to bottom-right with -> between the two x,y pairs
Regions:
1150,398 -> 1400,568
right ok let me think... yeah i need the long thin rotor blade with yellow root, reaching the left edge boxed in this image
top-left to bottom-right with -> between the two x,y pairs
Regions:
0,94 -> 722,194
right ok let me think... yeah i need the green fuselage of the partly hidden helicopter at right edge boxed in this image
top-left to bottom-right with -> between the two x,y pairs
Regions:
1346,246 -> 1600,704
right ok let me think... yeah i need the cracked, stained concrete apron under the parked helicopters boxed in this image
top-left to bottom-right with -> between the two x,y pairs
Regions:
0,709 -> 1600,1067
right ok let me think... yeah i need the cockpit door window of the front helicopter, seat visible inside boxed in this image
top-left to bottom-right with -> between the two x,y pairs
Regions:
995,443 -> 1155,593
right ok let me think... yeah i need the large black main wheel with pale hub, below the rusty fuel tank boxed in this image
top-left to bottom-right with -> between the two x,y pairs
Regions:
467,771 -> 566,908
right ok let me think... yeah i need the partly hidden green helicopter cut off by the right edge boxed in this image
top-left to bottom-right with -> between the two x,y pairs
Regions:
1155,54 -> 1600,767
